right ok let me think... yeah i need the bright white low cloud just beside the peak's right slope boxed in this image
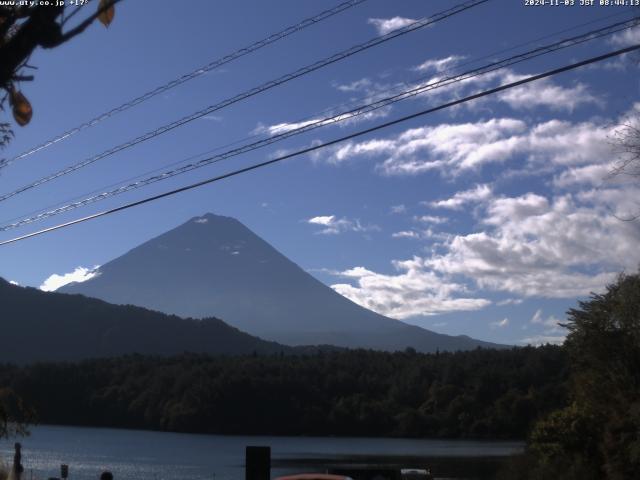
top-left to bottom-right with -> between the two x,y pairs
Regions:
332,257 -> 491,319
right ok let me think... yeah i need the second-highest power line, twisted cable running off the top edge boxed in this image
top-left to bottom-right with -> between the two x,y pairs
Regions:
0,0 -> 489,202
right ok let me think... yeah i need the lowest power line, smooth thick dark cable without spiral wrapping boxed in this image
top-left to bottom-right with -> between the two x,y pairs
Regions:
0,44 -> 640,246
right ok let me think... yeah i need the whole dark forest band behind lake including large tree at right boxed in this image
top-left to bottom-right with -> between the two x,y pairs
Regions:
0,274 -> 640,480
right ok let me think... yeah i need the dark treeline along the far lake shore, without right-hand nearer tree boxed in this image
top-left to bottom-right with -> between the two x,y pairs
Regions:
0,346 -> 568,438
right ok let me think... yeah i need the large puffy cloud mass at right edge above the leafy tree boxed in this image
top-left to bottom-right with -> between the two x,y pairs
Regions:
426,193 -> 640,298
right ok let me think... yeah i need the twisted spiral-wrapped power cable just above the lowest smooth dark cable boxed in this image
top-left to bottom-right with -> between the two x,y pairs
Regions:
0,17 -> 640,231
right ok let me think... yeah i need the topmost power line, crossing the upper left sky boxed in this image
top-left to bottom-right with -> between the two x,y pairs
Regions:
0,0 -> 367,170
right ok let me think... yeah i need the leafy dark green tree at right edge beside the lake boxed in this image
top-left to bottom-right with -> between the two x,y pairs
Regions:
530,274 -> 640,480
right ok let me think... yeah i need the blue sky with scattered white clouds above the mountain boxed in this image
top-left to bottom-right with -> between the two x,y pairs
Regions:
0,0 -> 640,344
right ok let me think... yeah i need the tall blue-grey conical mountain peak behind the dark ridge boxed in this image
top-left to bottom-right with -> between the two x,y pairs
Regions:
59,214 -> 504,352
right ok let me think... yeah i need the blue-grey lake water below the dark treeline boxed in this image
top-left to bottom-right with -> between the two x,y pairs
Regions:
0,426 -> 522,480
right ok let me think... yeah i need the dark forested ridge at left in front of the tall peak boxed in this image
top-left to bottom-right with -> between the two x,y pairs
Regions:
0,279 -> 291,363
